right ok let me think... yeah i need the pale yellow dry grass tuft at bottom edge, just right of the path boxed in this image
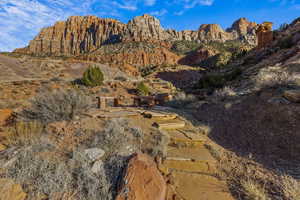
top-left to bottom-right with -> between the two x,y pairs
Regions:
241,180 -> 270,200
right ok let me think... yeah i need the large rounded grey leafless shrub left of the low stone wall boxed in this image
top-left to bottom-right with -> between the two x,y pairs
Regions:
22,89 -> 91,123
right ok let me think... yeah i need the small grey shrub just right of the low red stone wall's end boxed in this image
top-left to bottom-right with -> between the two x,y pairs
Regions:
166,92 -> 197,108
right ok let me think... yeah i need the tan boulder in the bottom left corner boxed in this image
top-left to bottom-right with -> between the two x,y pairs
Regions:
0,179 -> 27,200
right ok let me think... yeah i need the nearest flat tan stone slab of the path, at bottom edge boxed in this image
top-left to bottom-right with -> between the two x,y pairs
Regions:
167,172 -> 234,200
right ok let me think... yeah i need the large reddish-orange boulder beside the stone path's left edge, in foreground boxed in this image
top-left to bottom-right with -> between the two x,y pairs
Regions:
116,154 -> 167,200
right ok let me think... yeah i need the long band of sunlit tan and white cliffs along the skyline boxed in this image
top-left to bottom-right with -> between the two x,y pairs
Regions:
15,15 -> 256,56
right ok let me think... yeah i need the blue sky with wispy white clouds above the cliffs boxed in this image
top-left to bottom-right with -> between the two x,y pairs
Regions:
0,0 -> 300,51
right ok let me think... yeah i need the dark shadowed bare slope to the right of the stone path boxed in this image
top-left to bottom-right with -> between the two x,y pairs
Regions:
193,91 -> 300,177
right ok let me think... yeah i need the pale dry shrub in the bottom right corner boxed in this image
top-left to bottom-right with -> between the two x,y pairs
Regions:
281,175 -> 300,200
